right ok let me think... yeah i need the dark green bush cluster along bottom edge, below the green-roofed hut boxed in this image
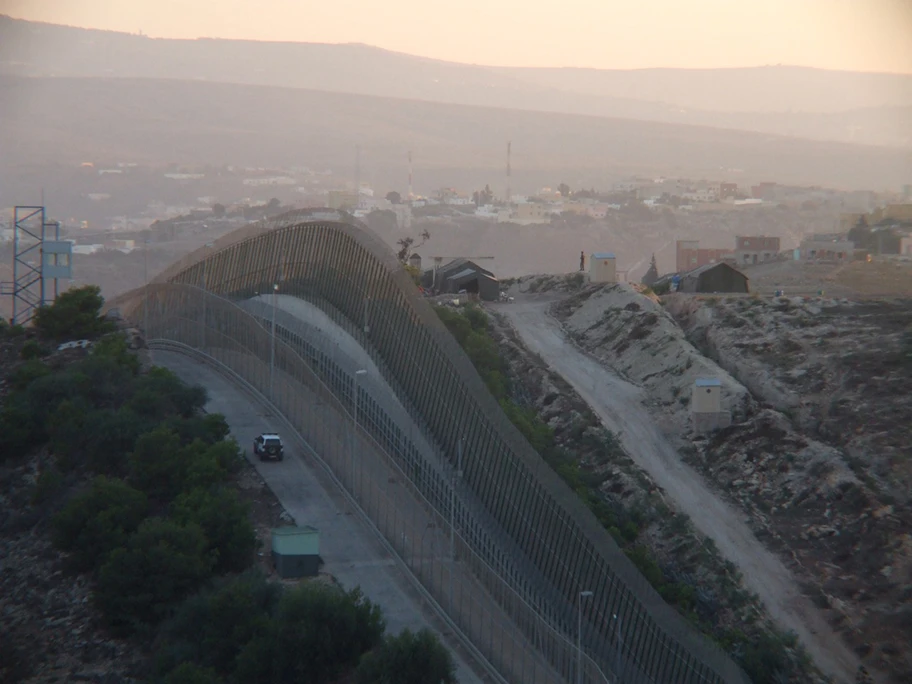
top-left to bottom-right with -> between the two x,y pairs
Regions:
154,571 -> 455,684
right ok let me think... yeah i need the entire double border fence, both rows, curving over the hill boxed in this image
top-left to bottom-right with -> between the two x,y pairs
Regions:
109,212 -> 748,684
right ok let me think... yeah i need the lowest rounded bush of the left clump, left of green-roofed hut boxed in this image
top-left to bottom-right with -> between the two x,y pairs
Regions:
95,518 -> 216,634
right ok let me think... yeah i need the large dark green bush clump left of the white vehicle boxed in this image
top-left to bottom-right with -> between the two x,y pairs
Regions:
0,335 -> 256,634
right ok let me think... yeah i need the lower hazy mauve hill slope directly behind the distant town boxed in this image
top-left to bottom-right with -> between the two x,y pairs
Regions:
0,76 -> 912,194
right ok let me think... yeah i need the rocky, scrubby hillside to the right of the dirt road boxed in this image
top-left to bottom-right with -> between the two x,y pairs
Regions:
553,285 -> 912,683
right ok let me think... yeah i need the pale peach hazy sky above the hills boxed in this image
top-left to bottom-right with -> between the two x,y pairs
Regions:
0,0 -> 912,73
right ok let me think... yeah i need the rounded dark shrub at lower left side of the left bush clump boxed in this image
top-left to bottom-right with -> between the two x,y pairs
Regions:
52,476 -> 149,571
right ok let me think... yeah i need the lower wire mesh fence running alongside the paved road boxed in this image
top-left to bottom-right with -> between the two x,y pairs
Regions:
124,285 -> 619,684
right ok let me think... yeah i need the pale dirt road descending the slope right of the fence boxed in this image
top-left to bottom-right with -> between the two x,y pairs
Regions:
491,295 -> 858,683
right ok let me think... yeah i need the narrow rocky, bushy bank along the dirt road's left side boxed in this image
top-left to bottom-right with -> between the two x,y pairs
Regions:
484,314 -> 824,684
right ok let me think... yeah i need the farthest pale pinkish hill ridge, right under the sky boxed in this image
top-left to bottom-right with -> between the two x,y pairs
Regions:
0,15 -> 912,148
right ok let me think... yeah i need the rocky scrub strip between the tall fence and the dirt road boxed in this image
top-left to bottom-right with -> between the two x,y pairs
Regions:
478,308 -> 824,684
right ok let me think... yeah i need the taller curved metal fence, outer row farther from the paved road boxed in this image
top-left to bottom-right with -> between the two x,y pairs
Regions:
110,213 -> 748,684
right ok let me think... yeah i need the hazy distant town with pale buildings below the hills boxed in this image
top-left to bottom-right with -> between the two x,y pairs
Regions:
0,162 -> 912,271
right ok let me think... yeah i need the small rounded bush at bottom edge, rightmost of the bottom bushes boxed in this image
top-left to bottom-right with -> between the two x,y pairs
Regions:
355,629 -> 456,684
